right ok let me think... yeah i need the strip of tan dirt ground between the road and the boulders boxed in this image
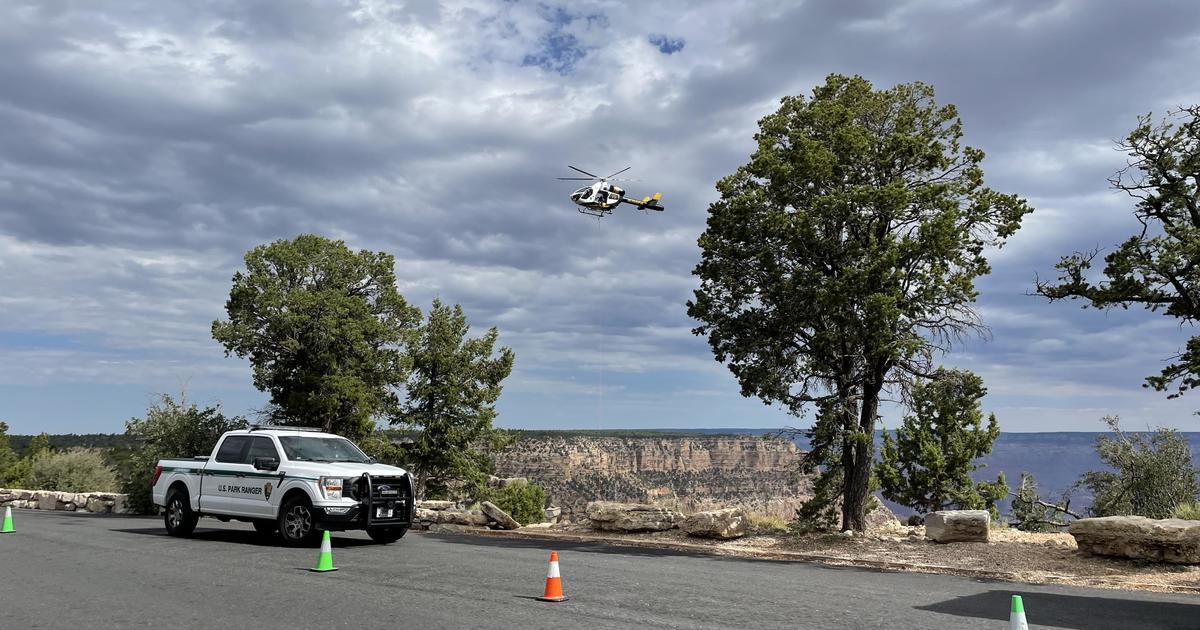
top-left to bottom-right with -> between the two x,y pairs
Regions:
521,518 -> 1200,594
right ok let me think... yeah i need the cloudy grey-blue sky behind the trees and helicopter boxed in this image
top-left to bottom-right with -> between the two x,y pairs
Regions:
0,0 -> 1200,433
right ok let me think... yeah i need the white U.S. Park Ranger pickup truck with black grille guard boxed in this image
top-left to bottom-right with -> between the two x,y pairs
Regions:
154,426 -> 414,546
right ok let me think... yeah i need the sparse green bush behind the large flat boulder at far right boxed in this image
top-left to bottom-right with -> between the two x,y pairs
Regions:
1079,415 -> 1198,518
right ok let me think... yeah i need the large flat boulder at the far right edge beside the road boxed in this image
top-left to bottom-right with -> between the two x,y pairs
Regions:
1067,516 -> 1200,564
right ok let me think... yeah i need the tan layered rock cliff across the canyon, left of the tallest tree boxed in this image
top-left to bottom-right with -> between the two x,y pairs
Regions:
496,432 -> 811,520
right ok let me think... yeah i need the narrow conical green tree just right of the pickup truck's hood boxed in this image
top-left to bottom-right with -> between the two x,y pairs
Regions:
392,300 -> 514,498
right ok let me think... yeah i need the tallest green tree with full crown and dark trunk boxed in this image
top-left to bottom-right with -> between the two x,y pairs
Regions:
688,74 -> 1031,529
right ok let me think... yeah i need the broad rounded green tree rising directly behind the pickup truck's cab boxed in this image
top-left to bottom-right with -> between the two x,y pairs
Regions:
212,234 -> 420,439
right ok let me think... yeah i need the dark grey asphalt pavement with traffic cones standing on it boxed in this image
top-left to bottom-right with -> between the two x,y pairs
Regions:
0,510 -> 1200,630
